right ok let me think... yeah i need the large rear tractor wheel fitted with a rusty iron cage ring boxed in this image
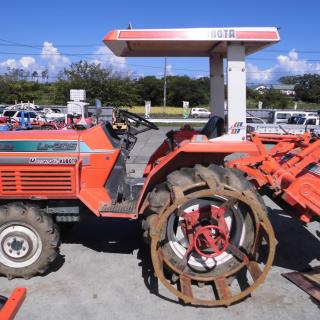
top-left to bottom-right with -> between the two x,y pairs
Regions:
142,164 -> 276,306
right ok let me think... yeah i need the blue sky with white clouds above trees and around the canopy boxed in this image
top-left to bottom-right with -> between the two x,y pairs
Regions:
0,0 -> 320,85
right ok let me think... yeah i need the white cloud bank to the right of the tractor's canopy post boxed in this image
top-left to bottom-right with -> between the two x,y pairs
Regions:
247,49 -> 320,83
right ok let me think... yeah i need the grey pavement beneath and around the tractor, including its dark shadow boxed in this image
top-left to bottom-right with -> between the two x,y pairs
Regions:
0,127 -> 320,320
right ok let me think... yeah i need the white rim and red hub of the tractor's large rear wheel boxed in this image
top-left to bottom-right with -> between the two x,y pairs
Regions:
167,200 -> 245,272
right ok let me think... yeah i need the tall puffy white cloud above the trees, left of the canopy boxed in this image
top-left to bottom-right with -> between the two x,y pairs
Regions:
41,41 -> 71,75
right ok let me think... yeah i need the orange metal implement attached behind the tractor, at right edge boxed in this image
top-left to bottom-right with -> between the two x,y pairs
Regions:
227,133 -> 320,223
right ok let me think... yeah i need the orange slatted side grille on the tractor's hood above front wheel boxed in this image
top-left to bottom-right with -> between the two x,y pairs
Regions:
0,169 -> 75,194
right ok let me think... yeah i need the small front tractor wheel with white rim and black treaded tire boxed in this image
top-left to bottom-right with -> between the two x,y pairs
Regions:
0,203 -> 60,279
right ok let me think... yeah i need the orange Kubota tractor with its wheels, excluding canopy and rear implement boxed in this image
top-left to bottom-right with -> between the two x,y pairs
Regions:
0,111 -> 276,306
